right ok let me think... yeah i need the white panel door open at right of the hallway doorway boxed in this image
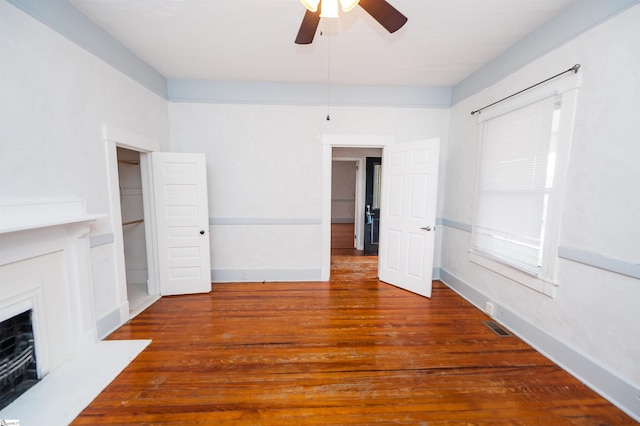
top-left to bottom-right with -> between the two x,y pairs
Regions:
378,139 -> 440,297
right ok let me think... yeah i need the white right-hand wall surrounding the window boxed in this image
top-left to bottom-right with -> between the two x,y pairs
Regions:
441,1 -> 640,412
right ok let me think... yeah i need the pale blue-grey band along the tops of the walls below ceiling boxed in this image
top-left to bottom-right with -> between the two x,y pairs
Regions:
8,0 -> 640,108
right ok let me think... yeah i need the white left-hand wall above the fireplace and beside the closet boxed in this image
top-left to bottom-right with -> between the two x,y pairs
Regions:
0,1 -> 169,332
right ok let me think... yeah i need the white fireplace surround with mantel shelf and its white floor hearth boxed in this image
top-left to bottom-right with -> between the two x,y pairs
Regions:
0,200 -> 150,425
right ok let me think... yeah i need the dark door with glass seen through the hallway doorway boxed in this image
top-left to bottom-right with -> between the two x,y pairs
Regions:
364,157 -> 382,256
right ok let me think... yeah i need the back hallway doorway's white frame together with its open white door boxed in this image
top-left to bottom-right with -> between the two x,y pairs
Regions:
321,135 -> 440,297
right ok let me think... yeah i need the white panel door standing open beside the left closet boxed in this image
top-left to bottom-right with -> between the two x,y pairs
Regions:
151,152 -> 211,296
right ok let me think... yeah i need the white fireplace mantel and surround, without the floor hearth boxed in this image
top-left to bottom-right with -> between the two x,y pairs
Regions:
0,200 -> 106,377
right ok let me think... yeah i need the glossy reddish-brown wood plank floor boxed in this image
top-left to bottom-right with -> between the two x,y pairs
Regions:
74,255 -> 635,426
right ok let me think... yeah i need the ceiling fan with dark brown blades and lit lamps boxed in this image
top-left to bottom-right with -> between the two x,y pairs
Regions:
296,0 -> 407,44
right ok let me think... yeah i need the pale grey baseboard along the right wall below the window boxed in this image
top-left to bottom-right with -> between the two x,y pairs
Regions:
440,269 -> 640,421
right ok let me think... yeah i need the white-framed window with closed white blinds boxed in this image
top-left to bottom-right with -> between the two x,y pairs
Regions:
470,81 -> 576,296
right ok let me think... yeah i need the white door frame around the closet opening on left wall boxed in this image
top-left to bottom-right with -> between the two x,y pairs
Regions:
102,125 -> 160,323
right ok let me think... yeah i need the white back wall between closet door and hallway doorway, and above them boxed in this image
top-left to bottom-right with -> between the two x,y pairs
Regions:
169,102 -> 449,281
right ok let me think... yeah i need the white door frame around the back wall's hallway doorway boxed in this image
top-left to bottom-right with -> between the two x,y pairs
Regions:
320,134 -> 396,281
